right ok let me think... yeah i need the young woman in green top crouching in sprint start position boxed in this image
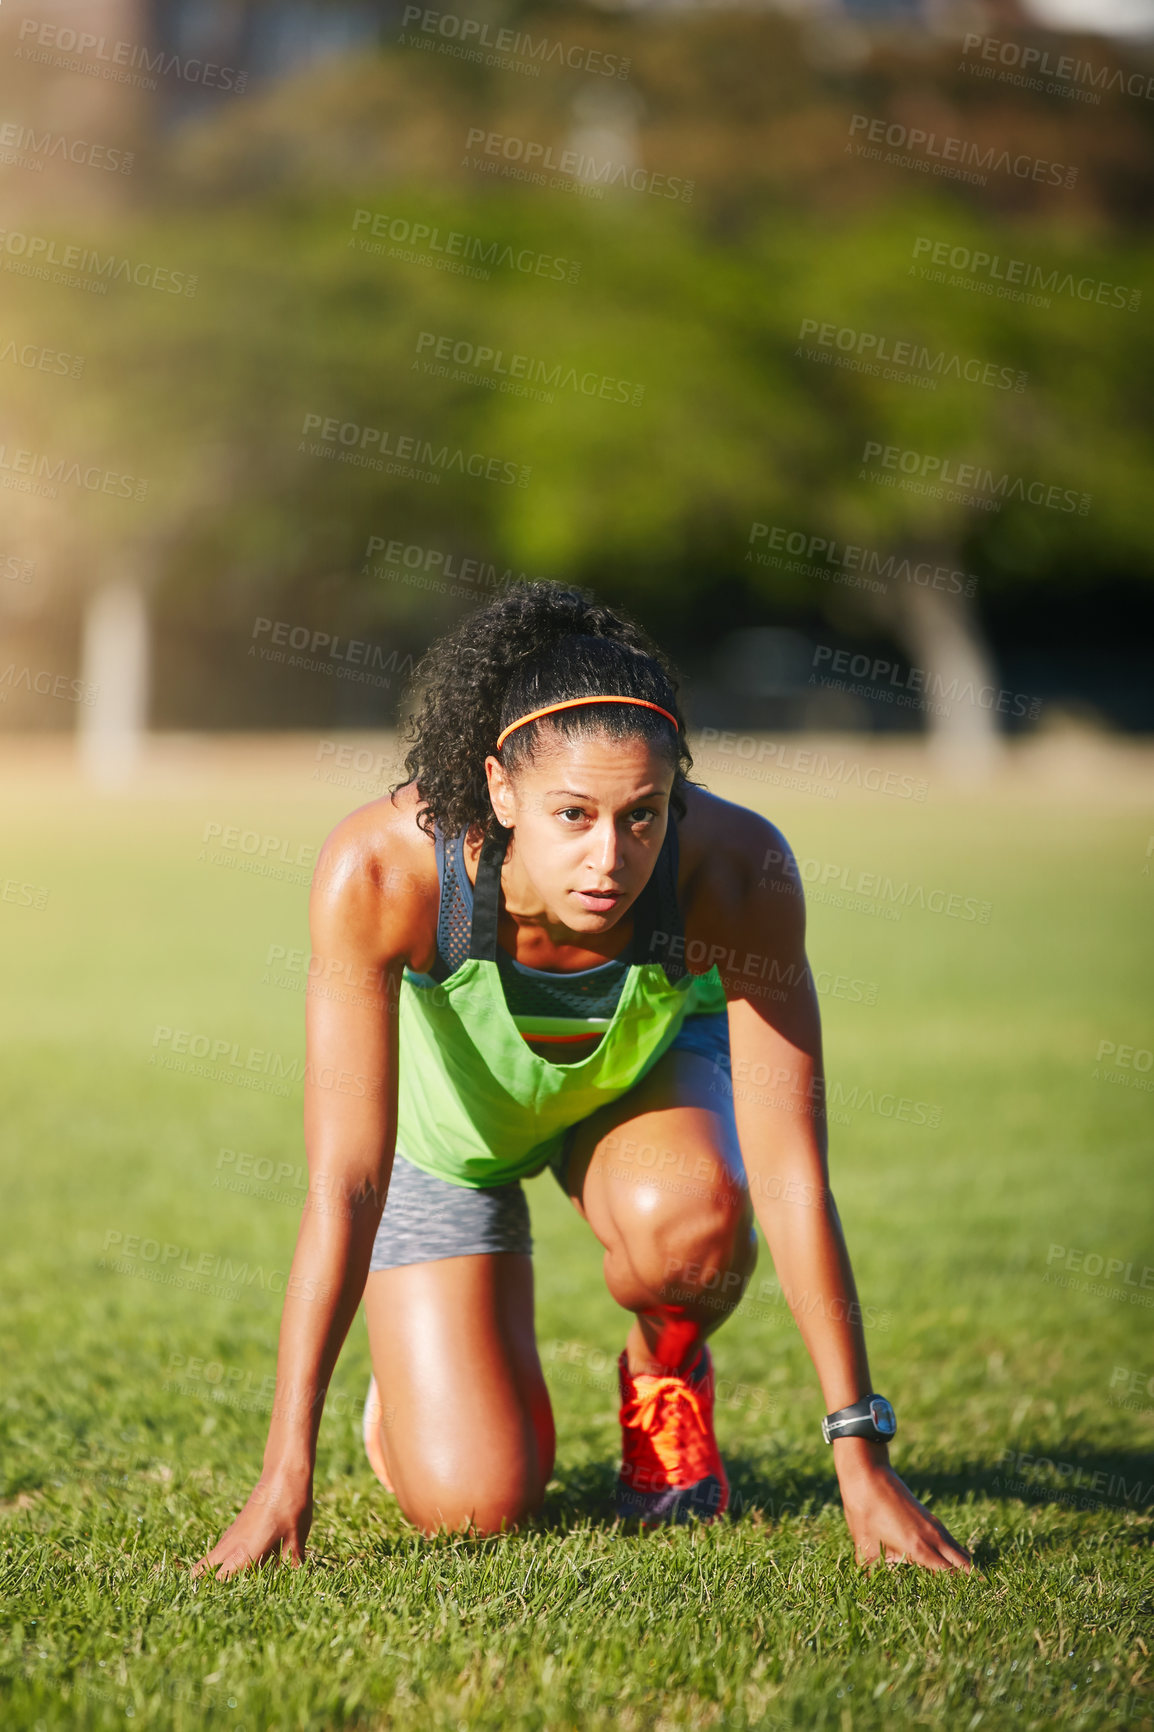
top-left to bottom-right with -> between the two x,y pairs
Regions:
196,584 -> 970,1578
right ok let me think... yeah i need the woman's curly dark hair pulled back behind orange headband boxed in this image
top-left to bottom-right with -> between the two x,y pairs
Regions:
390,582 -> 693,837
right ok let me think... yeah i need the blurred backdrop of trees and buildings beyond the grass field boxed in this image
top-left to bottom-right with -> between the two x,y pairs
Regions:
0,0 -> 1154,781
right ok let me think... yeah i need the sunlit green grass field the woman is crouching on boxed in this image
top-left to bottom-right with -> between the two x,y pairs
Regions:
0,745 -> 1154,1732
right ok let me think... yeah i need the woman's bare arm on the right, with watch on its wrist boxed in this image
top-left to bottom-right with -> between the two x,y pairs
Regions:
686,802 -> 970,1569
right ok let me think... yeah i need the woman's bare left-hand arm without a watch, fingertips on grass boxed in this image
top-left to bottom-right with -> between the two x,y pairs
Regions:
192,809 -> 421,1580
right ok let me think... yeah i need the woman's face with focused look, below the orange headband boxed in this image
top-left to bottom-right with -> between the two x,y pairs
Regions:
485,734 -> 674,934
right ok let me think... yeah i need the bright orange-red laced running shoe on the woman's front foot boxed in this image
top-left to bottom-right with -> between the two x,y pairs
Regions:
617,1342 -> 729,1524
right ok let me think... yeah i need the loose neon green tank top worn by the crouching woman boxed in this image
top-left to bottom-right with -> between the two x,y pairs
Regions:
397,819 -> 726,1188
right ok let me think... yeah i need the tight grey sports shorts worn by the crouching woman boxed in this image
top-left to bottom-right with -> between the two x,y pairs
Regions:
369,1015 -> 729,1275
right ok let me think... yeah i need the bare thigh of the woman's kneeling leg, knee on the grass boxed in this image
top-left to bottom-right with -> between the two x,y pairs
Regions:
364,1252 -> 554,1533
